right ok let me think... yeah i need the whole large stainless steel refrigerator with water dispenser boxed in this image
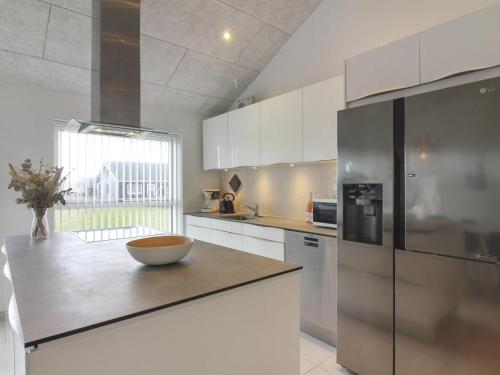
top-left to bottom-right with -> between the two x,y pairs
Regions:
337,78 -> 500,375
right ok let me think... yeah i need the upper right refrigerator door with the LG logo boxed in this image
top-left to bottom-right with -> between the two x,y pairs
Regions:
405,78 -> 500,263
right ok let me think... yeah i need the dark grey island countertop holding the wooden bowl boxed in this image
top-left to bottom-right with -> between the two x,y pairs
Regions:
5,233 -> 301,347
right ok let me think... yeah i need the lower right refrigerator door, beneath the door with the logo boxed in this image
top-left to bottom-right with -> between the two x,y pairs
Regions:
395,250 -> 500,375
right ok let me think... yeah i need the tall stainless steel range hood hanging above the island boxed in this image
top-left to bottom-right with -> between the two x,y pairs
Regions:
68,0 -> 141,136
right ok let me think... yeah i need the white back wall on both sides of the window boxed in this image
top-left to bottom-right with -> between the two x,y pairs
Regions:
0,82 -> 219,236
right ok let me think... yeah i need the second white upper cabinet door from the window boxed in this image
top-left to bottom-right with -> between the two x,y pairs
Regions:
228,104 -> 260,168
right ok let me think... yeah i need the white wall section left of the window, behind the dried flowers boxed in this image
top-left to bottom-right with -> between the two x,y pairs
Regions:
0,83 -> 90,235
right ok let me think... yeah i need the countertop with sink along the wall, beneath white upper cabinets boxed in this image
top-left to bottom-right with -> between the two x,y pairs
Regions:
184,212 -> 337,237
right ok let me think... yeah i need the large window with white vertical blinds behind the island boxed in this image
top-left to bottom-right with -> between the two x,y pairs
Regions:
54,122 -> 182,241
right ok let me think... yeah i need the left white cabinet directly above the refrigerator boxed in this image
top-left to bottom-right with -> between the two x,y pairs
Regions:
346,35 -> 420,102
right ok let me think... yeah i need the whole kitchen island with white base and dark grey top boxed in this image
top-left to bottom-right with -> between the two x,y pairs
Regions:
2,233 -> 300,375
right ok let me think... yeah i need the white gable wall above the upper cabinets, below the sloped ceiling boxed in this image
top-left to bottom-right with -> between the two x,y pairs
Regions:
236,0 -> 500,100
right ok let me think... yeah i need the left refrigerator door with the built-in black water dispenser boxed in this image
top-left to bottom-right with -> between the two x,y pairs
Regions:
337,102 -> 394,375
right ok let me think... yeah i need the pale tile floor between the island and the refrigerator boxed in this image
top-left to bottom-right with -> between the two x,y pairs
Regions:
300,333 -> 353,375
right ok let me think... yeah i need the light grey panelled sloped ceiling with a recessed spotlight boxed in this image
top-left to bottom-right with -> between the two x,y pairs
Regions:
0,0 -> 322,116
